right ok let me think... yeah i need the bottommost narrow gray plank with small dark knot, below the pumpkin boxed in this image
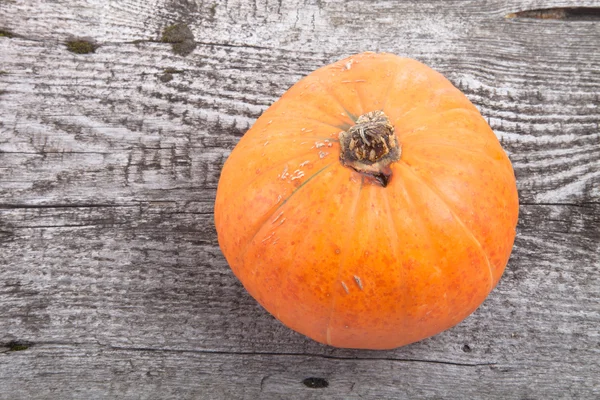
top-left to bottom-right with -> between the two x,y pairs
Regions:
0,344 -> 599,400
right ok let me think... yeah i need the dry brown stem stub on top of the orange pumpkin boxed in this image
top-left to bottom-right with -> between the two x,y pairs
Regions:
339,111 -> 401,187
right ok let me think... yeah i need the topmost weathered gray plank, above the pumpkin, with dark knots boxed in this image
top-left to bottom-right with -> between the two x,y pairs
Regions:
0,0 -> 599,45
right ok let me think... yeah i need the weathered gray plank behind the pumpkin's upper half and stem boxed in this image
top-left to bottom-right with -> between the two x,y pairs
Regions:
0,39 -> 600,203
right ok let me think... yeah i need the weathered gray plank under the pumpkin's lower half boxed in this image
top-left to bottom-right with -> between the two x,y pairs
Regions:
0,205 -> 600,368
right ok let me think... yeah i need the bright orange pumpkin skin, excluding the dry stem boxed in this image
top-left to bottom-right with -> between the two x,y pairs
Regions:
215,53 -> 518,349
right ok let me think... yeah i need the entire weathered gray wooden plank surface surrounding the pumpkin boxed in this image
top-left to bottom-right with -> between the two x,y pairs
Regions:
0,0 -> 600,399
